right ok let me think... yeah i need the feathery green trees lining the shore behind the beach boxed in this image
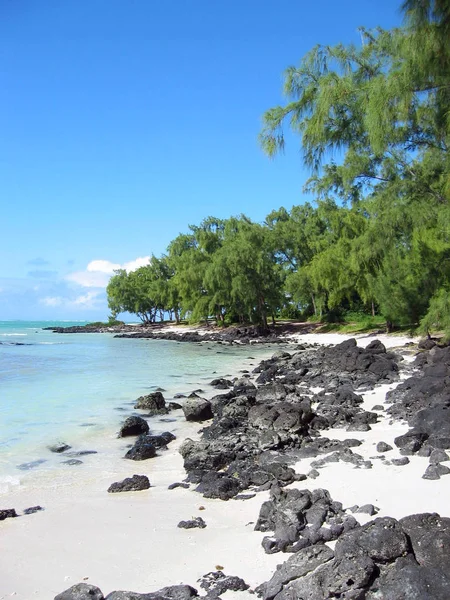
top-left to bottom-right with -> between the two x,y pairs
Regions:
107,0 -> 450,332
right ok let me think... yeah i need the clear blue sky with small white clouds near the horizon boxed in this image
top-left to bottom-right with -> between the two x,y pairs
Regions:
0,0 -> 401,320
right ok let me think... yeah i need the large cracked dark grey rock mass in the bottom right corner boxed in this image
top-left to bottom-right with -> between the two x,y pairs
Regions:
259,514 -> 450,600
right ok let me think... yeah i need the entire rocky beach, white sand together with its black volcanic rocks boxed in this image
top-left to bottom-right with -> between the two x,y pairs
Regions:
2,326 -> 450,600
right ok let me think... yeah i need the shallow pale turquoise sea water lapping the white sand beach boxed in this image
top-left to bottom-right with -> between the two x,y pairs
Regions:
0,321 -> 270,493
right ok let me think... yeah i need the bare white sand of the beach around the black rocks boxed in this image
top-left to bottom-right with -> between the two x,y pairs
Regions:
0,334 -> 450,600
